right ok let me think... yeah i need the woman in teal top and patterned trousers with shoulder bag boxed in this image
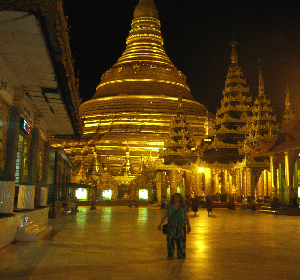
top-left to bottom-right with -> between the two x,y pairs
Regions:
157,193 -> 191,259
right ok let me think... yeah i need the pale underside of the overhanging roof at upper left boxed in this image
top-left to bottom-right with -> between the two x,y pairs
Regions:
0,10 -> 78,135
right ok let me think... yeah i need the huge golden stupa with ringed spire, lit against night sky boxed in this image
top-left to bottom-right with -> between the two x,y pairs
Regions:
64,0 -> 207,178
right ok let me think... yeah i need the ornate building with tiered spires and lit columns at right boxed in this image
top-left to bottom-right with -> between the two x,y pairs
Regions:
198,42 -> 300,205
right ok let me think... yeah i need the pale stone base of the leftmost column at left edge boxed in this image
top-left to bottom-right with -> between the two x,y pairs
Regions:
0,181 -> 15,214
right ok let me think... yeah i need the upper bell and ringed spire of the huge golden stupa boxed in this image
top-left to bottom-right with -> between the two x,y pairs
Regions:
93,0 -> 194,100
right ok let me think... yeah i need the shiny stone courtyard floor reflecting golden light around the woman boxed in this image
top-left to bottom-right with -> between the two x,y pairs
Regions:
0,206 -> 300,280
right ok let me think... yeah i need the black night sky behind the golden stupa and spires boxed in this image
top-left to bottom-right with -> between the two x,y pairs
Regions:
64,0 -> 300,119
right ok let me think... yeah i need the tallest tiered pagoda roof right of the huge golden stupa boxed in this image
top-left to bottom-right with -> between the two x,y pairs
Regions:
204,42 -> 252,163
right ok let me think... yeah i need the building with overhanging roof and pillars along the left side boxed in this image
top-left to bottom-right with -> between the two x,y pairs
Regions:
0,0 -> 82,248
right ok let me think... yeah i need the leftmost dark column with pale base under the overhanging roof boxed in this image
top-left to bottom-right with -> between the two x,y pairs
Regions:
0,87 -> 26,215
